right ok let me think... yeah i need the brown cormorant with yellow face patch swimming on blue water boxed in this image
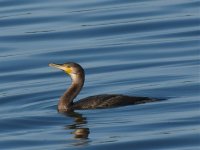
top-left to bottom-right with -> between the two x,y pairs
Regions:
49,62 -> 158,112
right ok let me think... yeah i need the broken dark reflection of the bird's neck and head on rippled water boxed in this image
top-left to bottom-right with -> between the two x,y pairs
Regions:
63,111 -> 90,139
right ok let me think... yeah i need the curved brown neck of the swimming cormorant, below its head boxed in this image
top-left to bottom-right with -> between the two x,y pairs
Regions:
58,74 -> 84,112
